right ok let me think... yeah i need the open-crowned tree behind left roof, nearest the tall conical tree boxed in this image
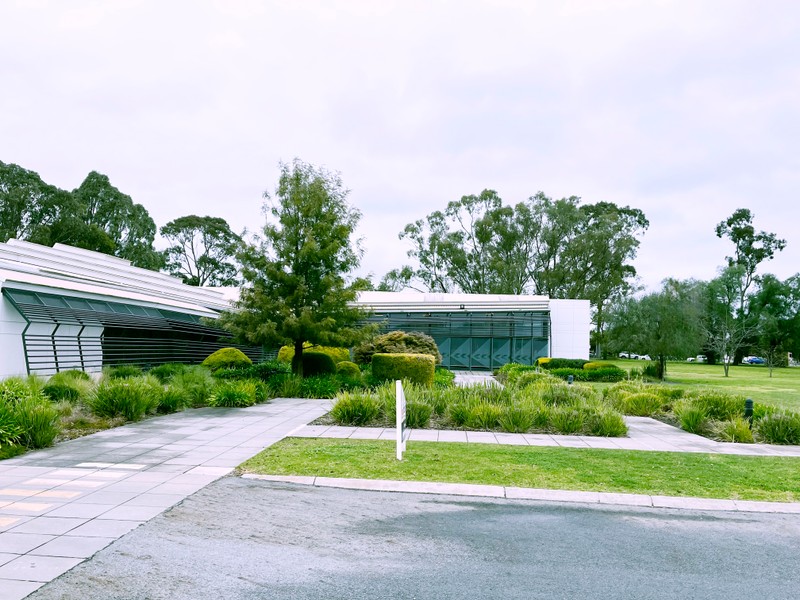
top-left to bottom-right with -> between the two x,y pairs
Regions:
161,215 -> 243,286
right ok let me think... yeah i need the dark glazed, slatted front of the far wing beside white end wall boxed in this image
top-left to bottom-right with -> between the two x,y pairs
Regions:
369,311 -> 550,370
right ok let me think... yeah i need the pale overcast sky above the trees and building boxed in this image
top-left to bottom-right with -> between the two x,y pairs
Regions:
0,0 -> 800,288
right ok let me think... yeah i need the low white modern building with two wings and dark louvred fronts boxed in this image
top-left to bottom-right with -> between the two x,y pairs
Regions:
0,240 -> 591,377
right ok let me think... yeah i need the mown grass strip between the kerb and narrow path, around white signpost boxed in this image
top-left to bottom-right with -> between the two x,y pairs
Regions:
239,438 -> 800,502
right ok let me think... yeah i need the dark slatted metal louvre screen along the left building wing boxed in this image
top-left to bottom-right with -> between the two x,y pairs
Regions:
3,288 -> 264,374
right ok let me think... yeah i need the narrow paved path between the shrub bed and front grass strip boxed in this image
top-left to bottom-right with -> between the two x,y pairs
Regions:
293,417 -> 800,456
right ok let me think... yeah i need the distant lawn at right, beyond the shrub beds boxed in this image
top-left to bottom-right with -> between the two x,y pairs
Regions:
613,360 -> 800,411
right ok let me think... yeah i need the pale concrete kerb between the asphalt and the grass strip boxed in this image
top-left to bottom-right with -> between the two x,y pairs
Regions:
241,473 -> 800,514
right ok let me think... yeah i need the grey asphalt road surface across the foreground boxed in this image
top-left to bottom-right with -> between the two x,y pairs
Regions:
30,477 -> 800,600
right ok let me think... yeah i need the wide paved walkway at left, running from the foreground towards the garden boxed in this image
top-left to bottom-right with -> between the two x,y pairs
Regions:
0,399 -> 330,600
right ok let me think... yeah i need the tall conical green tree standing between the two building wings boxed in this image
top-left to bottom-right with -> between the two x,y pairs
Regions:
219,160 -> 372,374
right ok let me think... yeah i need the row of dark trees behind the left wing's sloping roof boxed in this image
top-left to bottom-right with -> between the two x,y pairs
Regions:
0,162 -> 242,285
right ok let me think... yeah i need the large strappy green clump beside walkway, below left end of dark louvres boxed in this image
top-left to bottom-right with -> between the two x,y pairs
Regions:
87,376 -> 164,421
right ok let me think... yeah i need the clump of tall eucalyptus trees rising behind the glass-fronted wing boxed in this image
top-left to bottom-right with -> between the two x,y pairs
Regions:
390,190 -> 649,354
